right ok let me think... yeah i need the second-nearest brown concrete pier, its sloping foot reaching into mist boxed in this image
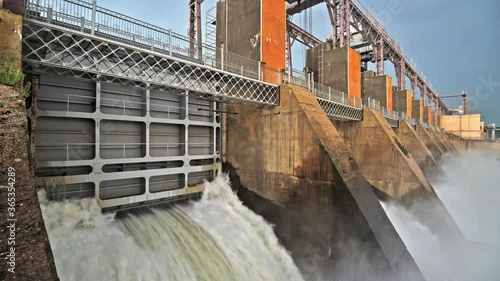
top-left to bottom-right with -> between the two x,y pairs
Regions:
335,109 -> 464,241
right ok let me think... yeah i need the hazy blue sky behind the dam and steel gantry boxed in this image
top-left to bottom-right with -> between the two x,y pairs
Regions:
97,0 -> 500,126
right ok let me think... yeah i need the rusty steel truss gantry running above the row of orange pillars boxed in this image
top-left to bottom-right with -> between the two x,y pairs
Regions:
287,0 -> 447,114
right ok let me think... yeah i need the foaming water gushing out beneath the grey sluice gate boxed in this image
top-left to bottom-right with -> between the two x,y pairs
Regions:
40,176 -> 302,281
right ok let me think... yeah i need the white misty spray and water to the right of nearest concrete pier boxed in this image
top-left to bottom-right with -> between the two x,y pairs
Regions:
382,151 -> 500,281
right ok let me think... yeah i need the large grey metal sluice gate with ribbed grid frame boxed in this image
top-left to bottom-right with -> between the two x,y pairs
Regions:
29,74 -> 221,208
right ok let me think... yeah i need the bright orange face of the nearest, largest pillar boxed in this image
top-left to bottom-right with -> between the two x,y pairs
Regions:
261,0 -> 286,83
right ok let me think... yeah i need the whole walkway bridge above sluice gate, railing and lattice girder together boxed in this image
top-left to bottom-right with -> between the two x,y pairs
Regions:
23,0 -> 280,104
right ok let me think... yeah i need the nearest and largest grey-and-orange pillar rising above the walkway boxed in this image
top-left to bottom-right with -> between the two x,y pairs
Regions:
216,0 -> 286,84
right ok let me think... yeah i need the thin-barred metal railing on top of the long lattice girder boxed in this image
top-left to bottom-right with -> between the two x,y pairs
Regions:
25,0 -> 282,85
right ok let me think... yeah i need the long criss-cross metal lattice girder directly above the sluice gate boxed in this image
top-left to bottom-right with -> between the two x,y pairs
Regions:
23,20 -> 279,104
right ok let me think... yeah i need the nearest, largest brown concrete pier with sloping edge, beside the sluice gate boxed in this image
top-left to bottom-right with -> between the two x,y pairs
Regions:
224,86 -> 423,280
